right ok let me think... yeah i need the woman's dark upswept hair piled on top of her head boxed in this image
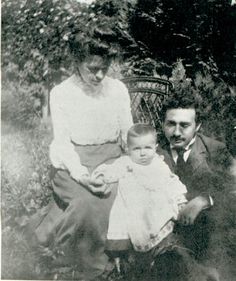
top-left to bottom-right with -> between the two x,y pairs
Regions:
70,18 -> 119,62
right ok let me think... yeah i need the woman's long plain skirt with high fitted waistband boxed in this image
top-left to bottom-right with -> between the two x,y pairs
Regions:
25,143 -> 121,280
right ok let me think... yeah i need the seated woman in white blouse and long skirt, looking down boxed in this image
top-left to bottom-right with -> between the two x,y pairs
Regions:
31,21 -> 133,280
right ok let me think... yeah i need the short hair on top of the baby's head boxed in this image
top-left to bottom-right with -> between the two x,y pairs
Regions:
127,123 -> 157,145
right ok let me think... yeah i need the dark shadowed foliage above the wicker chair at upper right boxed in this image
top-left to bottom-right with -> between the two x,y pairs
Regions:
130,0 -> 236,84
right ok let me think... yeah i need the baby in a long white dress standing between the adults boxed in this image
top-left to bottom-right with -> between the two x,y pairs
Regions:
93,124 -> 187,255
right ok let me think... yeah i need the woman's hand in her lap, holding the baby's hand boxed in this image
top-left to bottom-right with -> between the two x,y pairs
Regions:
79,173 -> 112,195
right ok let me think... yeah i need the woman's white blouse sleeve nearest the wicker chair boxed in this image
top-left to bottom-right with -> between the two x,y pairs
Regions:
119,81 -> 133,143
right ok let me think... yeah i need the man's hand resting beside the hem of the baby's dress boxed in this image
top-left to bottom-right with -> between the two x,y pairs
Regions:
178,196 -> 209,225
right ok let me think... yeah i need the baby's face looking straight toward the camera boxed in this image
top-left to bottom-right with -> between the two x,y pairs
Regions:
128,134 -> 156,166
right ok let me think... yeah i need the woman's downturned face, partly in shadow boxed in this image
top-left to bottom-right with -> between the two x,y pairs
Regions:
77,55 -> 111,87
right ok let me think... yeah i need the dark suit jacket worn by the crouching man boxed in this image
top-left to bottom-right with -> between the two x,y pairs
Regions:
157,134 -> 236,259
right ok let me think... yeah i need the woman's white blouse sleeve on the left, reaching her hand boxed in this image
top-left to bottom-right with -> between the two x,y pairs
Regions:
49,86 -> 88,179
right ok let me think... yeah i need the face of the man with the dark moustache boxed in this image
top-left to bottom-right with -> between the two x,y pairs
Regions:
163,108 -> 201,148
